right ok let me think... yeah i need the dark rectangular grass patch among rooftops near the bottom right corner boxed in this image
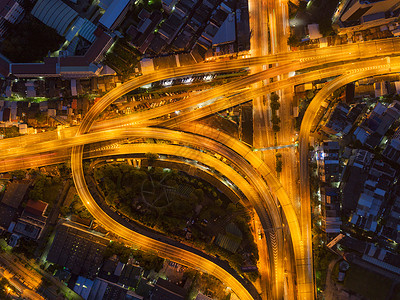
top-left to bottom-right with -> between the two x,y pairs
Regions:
344,264 -> 392,300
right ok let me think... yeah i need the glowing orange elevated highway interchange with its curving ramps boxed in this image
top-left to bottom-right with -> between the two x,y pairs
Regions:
0,35 -> 399,299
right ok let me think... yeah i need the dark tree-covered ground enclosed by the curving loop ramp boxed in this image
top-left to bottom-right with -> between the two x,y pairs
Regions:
94,164 -> 258,280
